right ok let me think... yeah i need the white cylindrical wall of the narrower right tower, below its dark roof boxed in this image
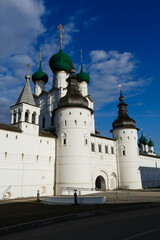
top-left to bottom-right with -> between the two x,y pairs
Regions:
113,127 -> 142,189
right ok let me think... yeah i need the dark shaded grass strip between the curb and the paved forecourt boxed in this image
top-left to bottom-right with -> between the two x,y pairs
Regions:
0,202 -> 152,228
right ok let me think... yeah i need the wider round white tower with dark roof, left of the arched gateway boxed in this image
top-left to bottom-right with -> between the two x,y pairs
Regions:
55,64 -> 92,195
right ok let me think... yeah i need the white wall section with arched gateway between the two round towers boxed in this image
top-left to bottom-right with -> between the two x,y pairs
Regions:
91,135 -> 118,190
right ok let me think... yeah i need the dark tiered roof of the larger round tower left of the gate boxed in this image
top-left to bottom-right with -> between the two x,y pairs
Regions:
58,64 -> 88,108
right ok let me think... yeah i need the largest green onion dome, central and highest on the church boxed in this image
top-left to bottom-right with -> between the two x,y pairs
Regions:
49,50 -> 72,73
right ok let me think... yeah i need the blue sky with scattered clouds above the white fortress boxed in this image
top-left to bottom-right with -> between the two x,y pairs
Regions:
0,0 -> 160,154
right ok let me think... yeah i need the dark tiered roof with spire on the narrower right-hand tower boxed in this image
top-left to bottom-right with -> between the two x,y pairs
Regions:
112,89 -> 136,129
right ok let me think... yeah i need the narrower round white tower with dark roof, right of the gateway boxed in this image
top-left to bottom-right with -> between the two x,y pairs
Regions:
111,86 -> 142,189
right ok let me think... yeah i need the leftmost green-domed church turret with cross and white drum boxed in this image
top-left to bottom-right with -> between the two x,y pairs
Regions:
32,48 -> 48,96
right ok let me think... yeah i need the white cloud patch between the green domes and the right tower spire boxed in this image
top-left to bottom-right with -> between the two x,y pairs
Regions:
88,50 -> 152,109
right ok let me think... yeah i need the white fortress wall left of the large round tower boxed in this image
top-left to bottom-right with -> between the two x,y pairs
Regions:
0,129 -> 56,199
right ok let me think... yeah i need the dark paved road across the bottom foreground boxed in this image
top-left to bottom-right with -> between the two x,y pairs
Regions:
0,207 -> 160,240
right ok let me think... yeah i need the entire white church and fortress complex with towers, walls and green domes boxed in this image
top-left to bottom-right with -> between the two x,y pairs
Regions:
0,25 -> 160,199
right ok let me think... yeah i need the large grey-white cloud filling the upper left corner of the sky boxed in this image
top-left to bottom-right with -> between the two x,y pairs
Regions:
0,0 -> 45,59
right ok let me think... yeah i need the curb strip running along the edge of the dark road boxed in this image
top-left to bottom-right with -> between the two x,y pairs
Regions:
0,203 -> 160,236
